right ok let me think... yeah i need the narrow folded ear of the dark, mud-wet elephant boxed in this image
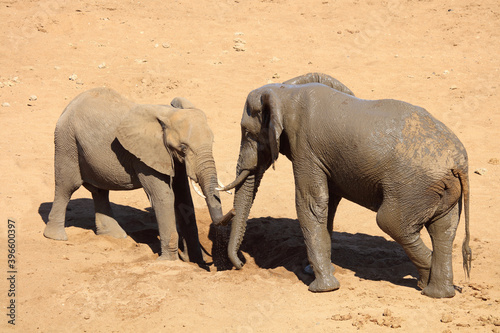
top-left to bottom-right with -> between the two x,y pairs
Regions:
261,89 -> 283,169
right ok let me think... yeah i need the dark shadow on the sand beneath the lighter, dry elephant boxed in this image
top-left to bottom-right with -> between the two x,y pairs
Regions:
38,199 -> 160,254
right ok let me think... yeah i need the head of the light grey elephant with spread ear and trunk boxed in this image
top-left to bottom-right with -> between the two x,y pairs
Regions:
116,99 -> 230,223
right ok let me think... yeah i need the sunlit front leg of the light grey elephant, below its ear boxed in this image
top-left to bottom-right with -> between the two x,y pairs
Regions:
136,162 -> 179,260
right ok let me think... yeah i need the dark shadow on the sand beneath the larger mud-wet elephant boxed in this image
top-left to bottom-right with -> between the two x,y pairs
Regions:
209,217 -> 418,288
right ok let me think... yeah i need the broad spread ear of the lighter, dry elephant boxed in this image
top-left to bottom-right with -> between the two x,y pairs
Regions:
116,105 -> 174,177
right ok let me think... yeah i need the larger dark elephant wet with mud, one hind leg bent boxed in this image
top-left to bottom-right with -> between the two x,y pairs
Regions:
220,79 -> 471,298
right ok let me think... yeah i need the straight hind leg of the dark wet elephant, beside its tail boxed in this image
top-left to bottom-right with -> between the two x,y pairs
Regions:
422,205 -> 460,298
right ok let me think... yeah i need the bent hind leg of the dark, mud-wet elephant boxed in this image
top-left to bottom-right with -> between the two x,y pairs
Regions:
377,200 -> 432,289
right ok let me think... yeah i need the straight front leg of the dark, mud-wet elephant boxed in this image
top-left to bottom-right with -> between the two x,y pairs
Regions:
294,168 -> 340,292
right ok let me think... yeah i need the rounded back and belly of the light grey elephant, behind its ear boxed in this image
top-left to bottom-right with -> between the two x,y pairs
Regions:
55,88 -> 143,190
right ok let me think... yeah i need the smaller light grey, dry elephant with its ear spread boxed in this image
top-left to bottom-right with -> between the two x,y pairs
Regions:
44,88 -> 232,263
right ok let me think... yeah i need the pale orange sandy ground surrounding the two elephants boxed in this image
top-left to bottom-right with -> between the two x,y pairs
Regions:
0,0 -> 500,332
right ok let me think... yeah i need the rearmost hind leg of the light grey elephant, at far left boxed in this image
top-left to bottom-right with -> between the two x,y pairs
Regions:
43,139 -> 82,240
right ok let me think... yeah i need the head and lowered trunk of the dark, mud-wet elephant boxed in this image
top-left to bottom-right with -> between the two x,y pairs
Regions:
219,85 -> 283,269
